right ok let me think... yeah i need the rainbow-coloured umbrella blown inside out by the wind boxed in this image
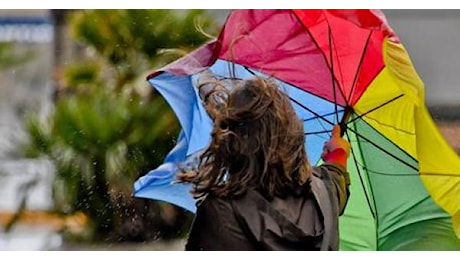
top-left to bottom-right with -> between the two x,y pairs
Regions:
134,10 -> 460,250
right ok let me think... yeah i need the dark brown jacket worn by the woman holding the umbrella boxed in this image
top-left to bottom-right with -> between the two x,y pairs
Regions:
185,164 -> 350,251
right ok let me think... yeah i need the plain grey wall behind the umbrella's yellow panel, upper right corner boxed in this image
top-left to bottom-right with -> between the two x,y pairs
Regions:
383,10 -> 460,107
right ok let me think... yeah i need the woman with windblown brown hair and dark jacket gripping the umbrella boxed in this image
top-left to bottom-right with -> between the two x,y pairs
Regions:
179,78 -> 350,250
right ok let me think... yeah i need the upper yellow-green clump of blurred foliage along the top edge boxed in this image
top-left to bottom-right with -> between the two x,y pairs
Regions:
72,9 -> 216,89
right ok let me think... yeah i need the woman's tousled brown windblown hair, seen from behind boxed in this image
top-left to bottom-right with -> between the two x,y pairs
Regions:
179,77 -> 312,199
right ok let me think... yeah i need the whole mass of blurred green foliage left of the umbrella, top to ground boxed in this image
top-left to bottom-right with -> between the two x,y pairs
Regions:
27,10 -> 217,241
